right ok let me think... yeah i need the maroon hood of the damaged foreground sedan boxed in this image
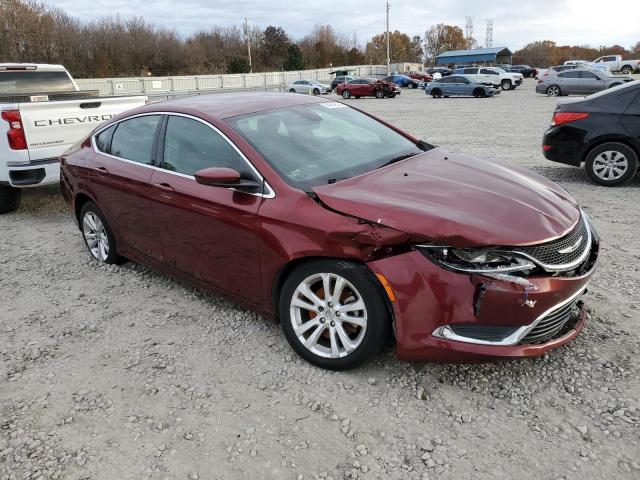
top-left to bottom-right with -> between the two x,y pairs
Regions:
313,148 -> 580,247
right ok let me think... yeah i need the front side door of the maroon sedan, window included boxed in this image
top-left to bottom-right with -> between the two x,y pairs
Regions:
150,115 -> 263,301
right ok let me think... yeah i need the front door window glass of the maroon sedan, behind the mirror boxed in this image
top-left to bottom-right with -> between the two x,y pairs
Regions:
162,116 -> 250,177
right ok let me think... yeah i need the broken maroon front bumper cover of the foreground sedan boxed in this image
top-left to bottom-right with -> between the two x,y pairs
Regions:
368,251 -> 593,363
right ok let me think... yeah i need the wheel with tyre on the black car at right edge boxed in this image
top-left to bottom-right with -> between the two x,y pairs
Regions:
584,142 -> 638,187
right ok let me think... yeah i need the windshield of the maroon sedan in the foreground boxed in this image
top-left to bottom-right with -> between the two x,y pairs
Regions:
227,102 -> 423,192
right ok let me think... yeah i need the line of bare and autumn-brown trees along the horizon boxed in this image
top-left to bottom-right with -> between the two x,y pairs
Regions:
0,0 -> 640,78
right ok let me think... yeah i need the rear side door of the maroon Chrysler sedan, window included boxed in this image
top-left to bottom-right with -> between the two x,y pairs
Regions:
87,114 -> 163,260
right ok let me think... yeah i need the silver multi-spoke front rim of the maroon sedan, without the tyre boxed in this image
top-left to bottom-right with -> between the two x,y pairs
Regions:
289,273 -> 367,358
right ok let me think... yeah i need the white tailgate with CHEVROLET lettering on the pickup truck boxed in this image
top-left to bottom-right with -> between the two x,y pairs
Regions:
18,96 -> 147,161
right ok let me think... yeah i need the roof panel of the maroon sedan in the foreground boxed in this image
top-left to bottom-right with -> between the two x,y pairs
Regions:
119,92 -> 331,120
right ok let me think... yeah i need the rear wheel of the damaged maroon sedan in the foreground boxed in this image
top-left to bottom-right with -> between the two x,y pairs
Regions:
79,202 -> 124,264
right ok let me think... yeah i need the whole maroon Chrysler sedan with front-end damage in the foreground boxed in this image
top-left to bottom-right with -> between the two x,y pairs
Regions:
60,92 -> 599,370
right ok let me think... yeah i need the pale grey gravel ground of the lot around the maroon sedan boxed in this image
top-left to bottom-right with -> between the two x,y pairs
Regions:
0,80 -> 640,480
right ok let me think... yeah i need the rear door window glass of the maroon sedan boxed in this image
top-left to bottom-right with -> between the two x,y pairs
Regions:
111,115 -> 160,165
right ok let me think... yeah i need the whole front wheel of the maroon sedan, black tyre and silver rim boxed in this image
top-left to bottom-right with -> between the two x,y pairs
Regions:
279,260 -> 391,370
